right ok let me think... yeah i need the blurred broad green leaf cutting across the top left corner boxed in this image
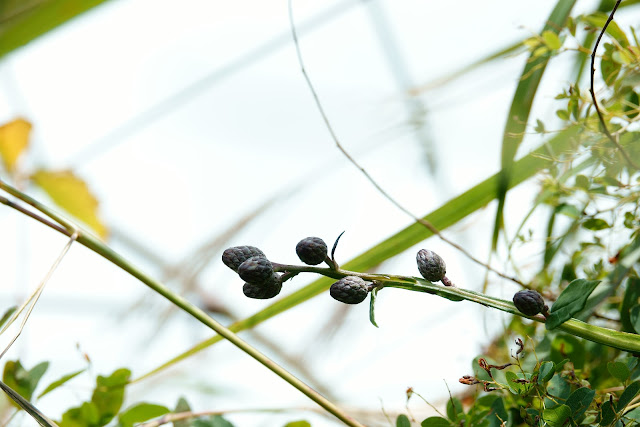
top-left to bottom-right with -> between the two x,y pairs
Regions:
0,0 -> 112,57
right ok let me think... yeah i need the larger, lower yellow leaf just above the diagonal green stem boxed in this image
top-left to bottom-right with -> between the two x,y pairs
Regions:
31,169 -> 107,238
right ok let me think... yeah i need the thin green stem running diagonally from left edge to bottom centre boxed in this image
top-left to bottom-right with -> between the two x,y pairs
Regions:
0,180 -> 364,427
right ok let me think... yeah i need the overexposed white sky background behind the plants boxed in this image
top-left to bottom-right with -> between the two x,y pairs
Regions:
0,0 -> 608,426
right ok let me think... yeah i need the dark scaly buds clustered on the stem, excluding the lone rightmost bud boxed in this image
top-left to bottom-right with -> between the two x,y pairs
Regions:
222,234 -> 453,310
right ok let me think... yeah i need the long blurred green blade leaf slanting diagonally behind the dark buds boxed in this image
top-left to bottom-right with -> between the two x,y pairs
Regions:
143,126 -> 580,377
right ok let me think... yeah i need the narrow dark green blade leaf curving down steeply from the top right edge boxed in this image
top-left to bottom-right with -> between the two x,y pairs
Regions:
492,0 -> 575,254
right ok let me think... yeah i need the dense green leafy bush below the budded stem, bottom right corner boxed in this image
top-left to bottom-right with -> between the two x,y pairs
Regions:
396,334 -> 640,427
